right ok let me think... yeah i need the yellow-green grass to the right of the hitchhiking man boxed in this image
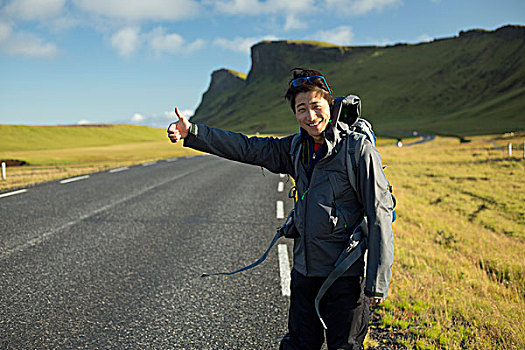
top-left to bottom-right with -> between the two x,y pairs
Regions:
368,135 -> 525,349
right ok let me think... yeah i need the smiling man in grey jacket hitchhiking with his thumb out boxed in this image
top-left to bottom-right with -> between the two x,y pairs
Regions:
168,69 -> 394,350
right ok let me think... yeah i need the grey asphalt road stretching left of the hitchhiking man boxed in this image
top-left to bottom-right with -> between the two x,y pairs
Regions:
0,156 -> 291,349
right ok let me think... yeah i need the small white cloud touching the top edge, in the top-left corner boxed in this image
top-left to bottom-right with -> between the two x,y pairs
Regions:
4,0 -> 66,20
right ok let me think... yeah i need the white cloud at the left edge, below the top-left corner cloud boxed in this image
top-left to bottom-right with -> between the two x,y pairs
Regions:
1,33 -> 57,58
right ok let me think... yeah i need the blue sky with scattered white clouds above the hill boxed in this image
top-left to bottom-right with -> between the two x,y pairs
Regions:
0,0 -> 525,127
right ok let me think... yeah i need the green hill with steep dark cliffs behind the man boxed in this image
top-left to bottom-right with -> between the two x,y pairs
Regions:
192,25 -> 525,135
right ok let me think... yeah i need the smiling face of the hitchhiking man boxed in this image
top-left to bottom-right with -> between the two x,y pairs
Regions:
295,91 -> 330,143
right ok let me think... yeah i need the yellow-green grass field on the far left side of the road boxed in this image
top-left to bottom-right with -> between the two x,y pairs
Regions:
0,125 -> 203,190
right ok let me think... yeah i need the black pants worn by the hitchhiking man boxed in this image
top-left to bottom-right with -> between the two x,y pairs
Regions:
279,269 -> 370,350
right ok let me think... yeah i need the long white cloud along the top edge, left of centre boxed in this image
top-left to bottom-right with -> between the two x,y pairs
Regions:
74,0 -> 200,21
